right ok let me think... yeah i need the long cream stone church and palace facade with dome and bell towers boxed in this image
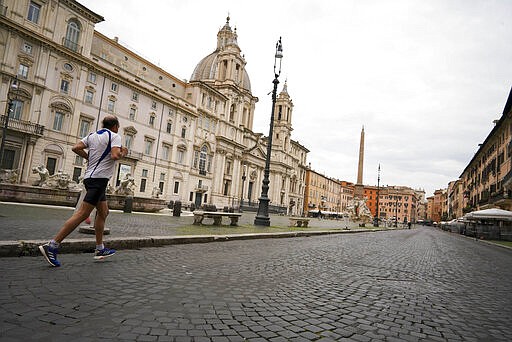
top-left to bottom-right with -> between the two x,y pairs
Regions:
0,0 -> 309,215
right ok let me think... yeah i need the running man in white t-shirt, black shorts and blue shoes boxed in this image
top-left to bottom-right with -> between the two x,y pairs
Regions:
39,115 -> 128,267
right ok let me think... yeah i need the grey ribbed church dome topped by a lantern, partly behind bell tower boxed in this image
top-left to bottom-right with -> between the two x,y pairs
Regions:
190,17 -> 251,92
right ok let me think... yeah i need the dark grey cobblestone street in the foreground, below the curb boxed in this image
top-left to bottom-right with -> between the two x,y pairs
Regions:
0,227 -> 512,342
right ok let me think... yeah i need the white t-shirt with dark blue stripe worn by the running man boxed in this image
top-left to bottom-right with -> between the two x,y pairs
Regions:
82,128 -> 121,179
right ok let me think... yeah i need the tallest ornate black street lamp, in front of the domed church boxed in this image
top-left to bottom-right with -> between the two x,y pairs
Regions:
254,37 -> 283,226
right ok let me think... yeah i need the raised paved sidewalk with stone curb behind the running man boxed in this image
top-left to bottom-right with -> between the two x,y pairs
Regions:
0,202 -> 396,256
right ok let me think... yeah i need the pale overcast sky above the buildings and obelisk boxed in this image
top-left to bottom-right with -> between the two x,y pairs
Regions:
79,0 -> 512,196
